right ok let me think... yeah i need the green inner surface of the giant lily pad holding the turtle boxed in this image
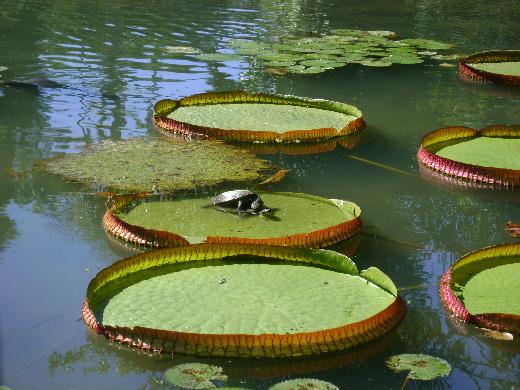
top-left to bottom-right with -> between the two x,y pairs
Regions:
118,193 -> 356,243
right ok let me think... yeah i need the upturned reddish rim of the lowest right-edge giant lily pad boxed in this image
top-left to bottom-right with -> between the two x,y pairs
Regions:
439,243 -> 520,333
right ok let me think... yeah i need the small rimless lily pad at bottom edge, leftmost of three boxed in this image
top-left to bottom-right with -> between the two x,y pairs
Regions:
164,363 -> 227,389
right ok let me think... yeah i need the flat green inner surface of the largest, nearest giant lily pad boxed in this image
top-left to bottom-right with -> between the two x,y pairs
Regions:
99,263 -> 395,334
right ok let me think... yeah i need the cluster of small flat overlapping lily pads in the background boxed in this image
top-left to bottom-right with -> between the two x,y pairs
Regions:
190,29 -> 459,74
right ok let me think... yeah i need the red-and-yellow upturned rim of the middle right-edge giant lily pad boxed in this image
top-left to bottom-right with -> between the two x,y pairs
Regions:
417,125 -> 520,188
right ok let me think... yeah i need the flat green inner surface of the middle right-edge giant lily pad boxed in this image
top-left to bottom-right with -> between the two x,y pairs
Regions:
436,137 -> 520,169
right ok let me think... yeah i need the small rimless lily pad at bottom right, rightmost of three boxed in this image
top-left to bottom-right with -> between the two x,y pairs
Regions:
386,353 -> 451,381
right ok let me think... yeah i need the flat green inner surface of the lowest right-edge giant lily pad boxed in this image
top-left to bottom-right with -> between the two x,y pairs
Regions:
462,259 -> 520,315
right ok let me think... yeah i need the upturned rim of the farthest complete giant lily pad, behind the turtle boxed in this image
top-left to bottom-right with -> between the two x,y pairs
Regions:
153,91 -> 365,143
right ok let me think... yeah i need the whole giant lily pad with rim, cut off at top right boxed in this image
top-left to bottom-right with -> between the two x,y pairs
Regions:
459,50 -> 520,86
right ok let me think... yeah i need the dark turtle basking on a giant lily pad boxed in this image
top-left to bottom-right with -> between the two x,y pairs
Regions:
211,190 -> 272,215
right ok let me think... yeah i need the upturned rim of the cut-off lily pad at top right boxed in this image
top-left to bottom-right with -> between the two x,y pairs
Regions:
459,50 -> 520,86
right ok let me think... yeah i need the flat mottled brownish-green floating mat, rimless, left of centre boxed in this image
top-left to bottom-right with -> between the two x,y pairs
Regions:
43,138 -> 269,192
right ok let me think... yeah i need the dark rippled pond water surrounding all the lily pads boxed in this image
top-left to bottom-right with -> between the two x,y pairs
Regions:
0,0 -> 520,390
